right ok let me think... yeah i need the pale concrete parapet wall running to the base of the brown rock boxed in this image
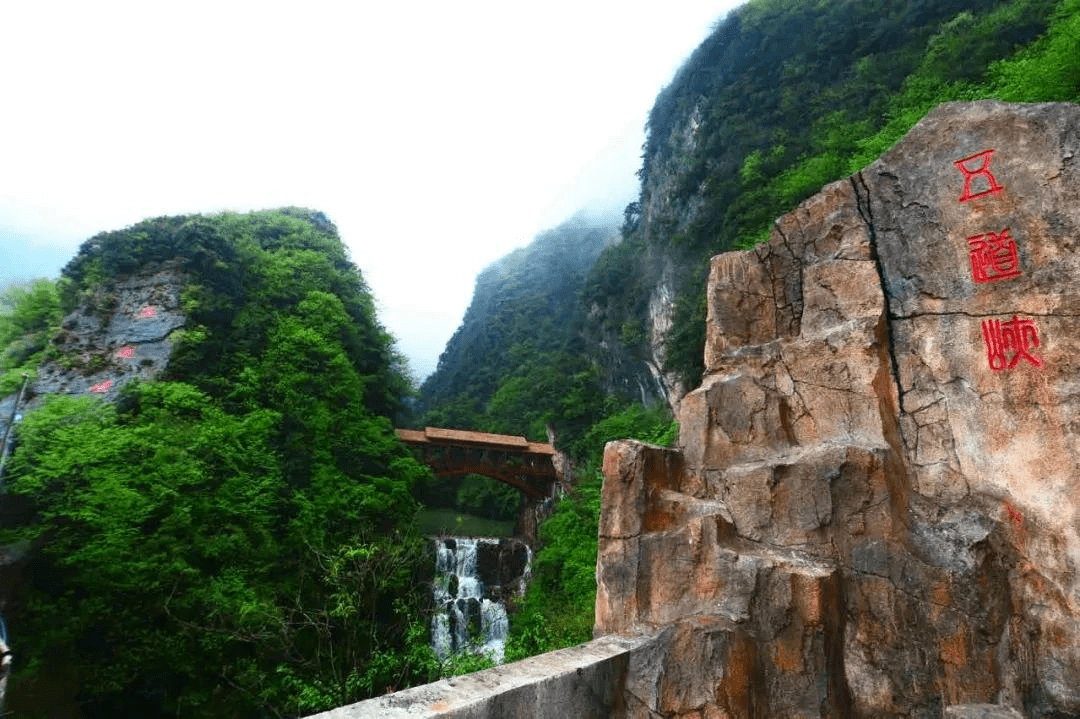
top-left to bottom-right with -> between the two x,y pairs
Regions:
310,636 -> 654,719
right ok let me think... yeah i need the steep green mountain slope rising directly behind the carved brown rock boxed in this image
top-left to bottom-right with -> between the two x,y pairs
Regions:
590,0 -> 1080,386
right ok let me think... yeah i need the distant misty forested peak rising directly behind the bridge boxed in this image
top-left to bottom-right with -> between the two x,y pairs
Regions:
412,211 -> 619,439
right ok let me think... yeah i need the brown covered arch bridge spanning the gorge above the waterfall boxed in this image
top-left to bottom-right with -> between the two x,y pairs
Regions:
397,426 -> 569,545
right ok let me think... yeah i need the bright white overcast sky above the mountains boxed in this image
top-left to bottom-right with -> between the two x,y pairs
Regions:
0,0 -> 741,379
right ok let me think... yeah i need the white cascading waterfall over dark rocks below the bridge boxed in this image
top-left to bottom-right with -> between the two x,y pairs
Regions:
431,537 -> 532,664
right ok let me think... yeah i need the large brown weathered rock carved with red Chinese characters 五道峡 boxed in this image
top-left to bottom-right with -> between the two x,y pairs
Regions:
596,103 -> 1080,718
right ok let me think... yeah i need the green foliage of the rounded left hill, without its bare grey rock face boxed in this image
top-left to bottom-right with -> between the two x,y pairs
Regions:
3,208 -> 437,717
